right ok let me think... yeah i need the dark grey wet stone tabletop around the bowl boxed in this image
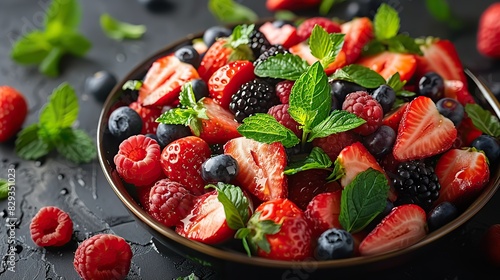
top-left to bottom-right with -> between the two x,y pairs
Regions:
0,0 -> 500,279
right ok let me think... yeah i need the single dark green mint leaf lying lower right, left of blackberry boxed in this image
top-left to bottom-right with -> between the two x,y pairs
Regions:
339,168 -> 389,233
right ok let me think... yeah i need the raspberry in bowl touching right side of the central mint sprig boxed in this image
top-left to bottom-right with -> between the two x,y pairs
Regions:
342,91 -> 384,136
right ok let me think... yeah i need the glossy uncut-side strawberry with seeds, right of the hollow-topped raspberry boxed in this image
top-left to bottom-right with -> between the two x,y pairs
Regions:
160,136 -> 212,195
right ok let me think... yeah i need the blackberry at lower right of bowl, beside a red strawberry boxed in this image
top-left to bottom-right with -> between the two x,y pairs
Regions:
393,160 -> 441,211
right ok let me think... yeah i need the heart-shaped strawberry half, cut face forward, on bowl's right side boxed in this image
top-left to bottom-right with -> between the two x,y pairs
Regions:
393,96 -> 457,161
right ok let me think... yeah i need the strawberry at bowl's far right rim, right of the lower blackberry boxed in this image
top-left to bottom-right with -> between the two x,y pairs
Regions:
435,148 -> 490,207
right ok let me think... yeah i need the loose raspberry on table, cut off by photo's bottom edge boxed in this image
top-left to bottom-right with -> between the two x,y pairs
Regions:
73,233 -> 132,280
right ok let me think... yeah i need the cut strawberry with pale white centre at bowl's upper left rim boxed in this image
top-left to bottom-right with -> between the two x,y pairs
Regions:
137,55 -> 200,106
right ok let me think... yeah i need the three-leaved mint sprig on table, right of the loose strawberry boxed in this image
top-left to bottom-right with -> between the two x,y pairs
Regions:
15,83 -> 97,163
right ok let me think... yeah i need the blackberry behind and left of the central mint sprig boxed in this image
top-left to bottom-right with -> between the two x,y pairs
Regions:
229,79 -> 280,122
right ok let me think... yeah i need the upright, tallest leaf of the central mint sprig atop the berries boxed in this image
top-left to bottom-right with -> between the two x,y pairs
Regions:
288,62 -> 331,129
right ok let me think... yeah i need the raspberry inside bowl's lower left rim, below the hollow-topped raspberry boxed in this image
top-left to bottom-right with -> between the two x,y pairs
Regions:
148,179 -> 195,227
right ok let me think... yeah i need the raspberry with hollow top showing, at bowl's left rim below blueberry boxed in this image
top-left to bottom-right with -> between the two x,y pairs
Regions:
114,134 -> 163,186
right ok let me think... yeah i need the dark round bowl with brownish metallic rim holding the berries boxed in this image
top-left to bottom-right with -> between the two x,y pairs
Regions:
97,31 -> 500,279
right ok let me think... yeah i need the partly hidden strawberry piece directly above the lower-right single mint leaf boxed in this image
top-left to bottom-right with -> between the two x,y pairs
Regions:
335,142 -> 385,187
